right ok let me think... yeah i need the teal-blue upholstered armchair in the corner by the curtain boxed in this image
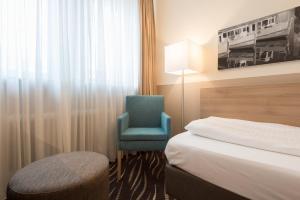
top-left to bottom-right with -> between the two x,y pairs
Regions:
118,96 -> 171,178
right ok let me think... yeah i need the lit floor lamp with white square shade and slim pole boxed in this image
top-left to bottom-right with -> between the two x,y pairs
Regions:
165,40 -> 200,130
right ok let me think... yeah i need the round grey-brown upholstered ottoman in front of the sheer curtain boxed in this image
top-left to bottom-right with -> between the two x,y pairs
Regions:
7,152 -> 109,200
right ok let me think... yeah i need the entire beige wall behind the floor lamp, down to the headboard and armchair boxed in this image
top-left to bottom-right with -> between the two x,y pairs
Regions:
155,0 -> 300,134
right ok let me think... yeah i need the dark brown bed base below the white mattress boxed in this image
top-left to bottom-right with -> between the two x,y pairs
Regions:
165,164 -> 247,200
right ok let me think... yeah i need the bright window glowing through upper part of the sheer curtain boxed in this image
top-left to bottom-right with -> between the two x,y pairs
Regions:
0,0 -> 140,88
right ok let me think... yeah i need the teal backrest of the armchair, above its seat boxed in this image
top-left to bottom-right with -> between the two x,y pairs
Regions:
126,96 -> 164,127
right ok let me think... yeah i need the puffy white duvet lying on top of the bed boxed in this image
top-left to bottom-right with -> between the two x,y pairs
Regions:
185,117 -> 300,156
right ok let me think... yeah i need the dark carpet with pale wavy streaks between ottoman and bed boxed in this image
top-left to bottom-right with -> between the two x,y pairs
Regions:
109,152 -> 171,200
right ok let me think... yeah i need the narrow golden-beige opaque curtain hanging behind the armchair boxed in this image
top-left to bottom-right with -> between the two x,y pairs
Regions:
140,0 -> 156,95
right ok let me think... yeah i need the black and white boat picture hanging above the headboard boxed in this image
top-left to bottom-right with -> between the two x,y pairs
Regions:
218,7 -> 300,70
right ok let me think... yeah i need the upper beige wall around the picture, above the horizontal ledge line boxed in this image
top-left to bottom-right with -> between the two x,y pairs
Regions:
155,0 -> 300,85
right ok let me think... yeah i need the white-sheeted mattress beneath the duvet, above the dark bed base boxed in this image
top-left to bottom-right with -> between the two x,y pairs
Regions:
165,132 -> 300,200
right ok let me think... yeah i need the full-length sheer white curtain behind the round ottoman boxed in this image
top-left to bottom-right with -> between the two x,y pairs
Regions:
0,0 -> 140,199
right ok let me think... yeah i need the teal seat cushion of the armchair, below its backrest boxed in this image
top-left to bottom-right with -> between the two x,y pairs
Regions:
120,128 -> 168,141
